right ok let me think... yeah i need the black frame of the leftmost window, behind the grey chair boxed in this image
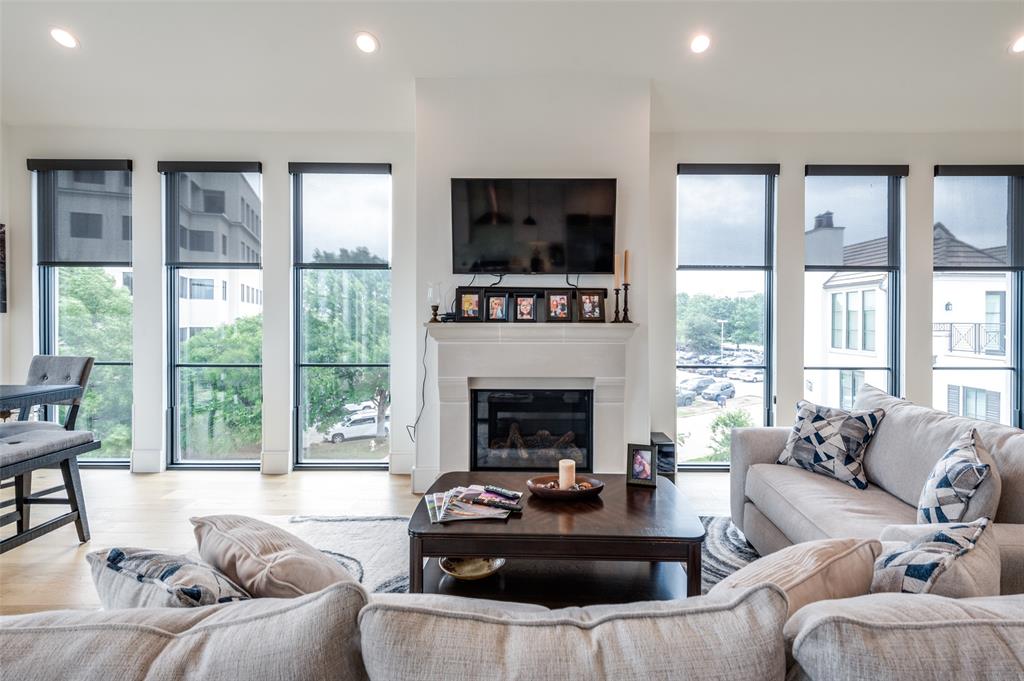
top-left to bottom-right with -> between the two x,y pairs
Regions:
26,159 -> 134,468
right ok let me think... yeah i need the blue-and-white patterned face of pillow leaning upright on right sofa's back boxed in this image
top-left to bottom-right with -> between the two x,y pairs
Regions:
918,428 -> 990,523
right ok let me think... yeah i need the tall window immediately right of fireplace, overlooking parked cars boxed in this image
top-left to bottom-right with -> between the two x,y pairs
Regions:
676,164 -> 778,466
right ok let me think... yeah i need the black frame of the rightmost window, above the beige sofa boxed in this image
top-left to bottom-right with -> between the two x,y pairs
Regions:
932,164 -> 1024,428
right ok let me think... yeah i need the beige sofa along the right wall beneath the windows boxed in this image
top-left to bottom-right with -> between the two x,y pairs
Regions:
730,385 -> 1024,594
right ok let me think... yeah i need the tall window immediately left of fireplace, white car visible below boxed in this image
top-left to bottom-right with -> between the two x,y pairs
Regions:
290,163 -> 391,465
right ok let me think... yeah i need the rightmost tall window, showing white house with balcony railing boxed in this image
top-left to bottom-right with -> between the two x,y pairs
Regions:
932,166 -> 1024,426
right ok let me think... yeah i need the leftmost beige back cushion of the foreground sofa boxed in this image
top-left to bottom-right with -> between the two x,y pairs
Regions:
0,583 -> 367,681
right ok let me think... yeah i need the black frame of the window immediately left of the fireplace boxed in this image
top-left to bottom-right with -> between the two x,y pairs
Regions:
296,163 -> 393,470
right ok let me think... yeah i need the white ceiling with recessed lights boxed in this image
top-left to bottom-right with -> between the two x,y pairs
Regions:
0,0 -> 1024,131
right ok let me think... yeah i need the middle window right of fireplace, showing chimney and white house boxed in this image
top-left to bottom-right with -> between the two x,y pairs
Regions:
804,166 -> 907,409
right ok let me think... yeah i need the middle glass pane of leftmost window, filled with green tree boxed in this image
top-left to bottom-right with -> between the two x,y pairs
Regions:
55,267 -> 132,360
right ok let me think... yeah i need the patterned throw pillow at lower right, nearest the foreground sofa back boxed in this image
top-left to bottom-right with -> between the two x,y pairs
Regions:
871,518 -> 1002,598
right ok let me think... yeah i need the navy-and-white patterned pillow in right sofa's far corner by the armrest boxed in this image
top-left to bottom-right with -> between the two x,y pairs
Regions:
778,399 -> 886,490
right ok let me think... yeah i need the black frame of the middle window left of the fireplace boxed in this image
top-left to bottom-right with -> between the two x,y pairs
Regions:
157,161 -> 263,470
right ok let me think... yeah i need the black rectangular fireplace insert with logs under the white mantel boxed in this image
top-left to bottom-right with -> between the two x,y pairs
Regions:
470,389 -> 594,471
